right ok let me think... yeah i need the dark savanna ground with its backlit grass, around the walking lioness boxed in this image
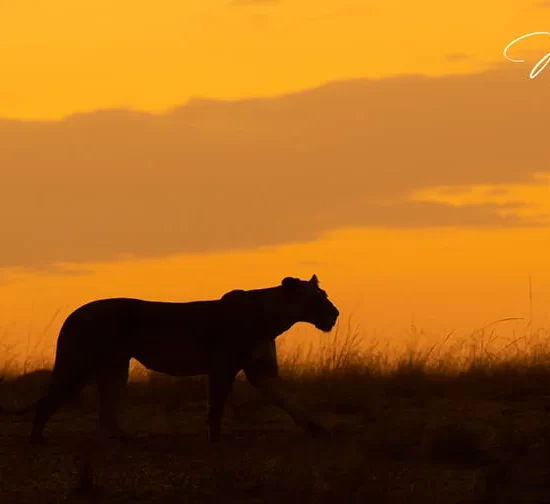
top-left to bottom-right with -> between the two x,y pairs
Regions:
0,320 -> 550,504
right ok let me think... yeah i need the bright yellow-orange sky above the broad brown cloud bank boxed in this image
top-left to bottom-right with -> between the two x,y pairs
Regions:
0,0 -> 550,119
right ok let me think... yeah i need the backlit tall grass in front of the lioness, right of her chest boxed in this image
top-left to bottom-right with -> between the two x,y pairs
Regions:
279,319 -> 550,375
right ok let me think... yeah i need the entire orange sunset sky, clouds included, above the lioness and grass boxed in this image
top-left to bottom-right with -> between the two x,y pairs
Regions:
0,0 -> 550,356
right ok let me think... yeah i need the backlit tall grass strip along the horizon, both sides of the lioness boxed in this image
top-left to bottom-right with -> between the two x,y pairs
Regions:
0,313 -> 550,379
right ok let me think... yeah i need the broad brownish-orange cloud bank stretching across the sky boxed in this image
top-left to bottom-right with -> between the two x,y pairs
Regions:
0,67 -> 550,269
